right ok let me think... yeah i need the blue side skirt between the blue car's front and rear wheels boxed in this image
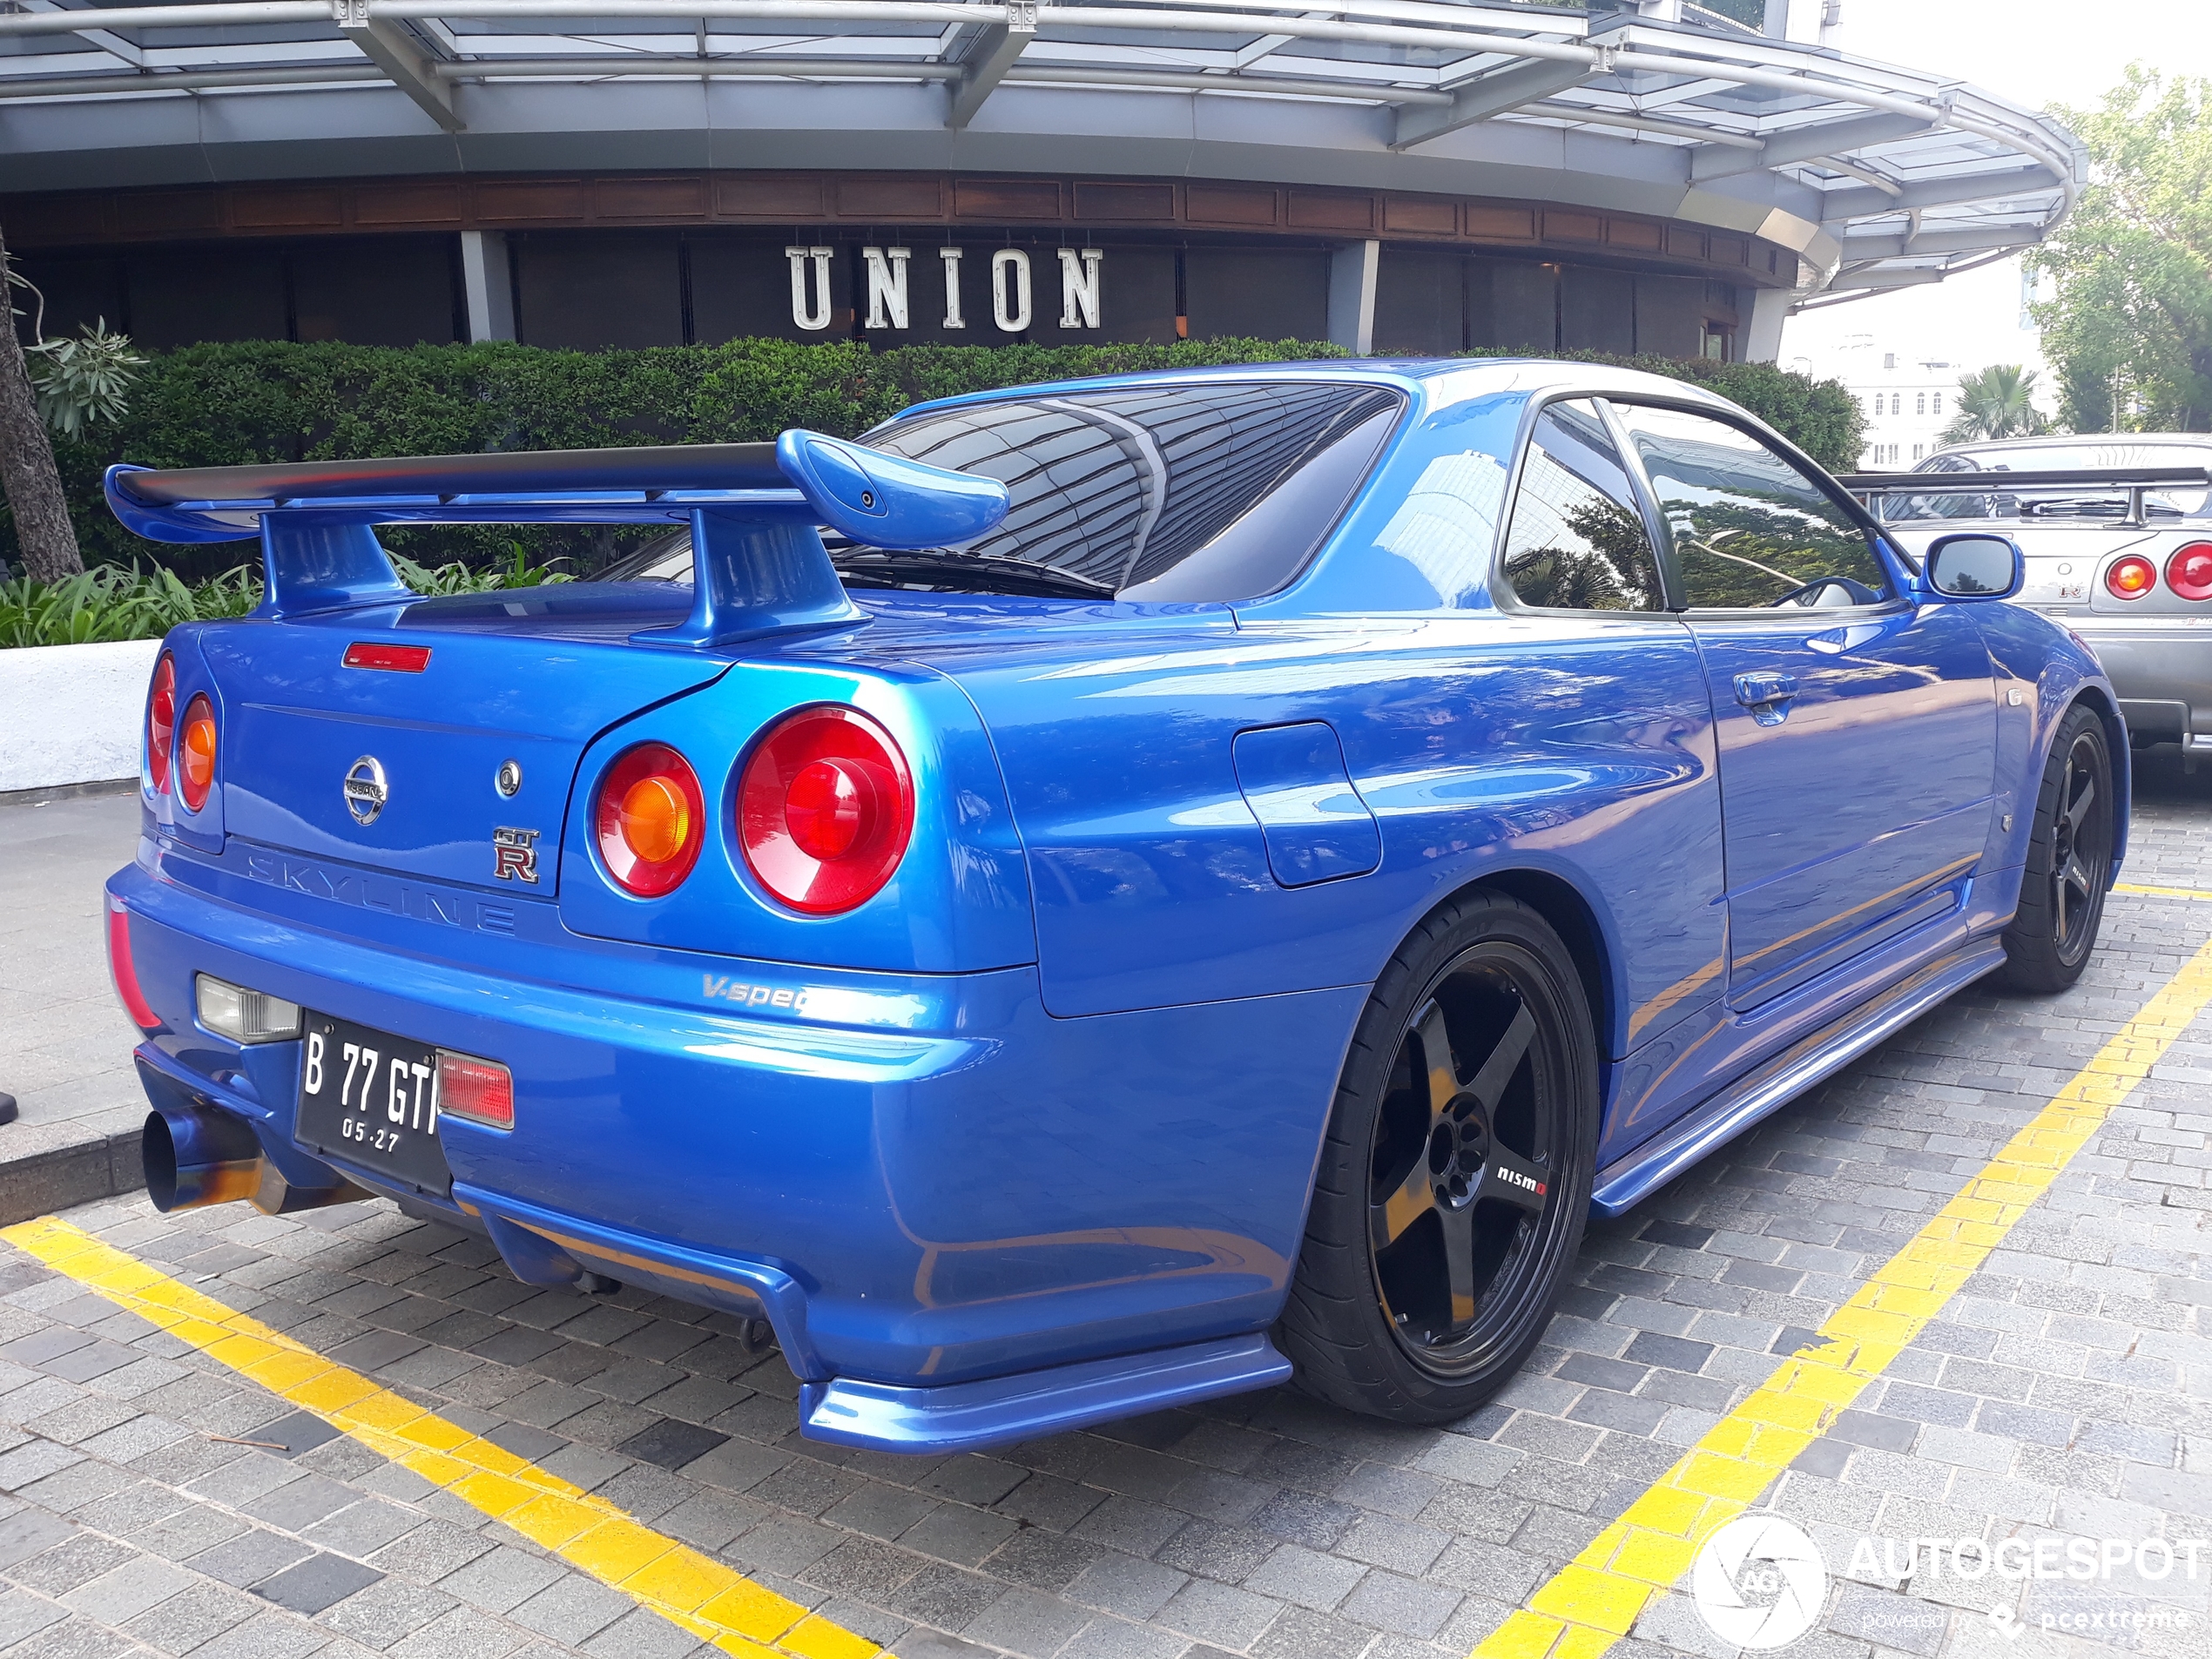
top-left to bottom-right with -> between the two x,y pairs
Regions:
1590,938 -> 2004,1214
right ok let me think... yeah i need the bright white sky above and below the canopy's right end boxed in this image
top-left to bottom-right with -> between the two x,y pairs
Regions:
1781,0 -> 2212,395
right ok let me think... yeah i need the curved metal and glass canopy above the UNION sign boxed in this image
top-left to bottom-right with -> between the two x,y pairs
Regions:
0,0 -> 2084,299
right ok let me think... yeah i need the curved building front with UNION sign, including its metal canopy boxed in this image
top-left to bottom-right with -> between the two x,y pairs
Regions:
0,0 -> 2080,358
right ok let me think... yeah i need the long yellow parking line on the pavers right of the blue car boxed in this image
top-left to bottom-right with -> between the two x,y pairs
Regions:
1475,945 -> 2212,1659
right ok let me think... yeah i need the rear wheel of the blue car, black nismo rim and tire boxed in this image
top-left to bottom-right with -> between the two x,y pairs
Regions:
1277,887 -> 1597,1425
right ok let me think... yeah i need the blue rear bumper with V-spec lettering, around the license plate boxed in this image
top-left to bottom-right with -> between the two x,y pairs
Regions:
108,845 -> 1365,1451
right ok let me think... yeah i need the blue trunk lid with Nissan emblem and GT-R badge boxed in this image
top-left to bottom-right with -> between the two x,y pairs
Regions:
197,584 -> 732,898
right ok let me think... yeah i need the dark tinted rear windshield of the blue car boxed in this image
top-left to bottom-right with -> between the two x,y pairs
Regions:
604,381 -> 1402,602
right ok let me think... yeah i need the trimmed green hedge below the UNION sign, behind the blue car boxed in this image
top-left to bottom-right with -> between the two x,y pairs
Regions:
0,339 -> 1858,577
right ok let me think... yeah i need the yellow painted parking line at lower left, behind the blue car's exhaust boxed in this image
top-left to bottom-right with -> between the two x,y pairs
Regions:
0,1217 -> 880,1659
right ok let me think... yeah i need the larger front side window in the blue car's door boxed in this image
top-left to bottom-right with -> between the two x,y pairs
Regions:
1617,402 -> 1892,610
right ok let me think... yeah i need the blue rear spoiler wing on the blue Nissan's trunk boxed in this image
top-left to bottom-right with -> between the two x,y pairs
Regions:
106,429 -> 1008,646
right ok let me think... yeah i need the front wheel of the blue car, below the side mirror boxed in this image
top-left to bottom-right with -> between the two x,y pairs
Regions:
2004,704 -> 2113,993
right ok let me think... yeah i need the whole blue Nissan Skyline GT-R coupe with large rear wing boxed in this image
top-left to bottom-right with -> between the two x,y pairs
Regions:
108,361 -> 2128,1451
